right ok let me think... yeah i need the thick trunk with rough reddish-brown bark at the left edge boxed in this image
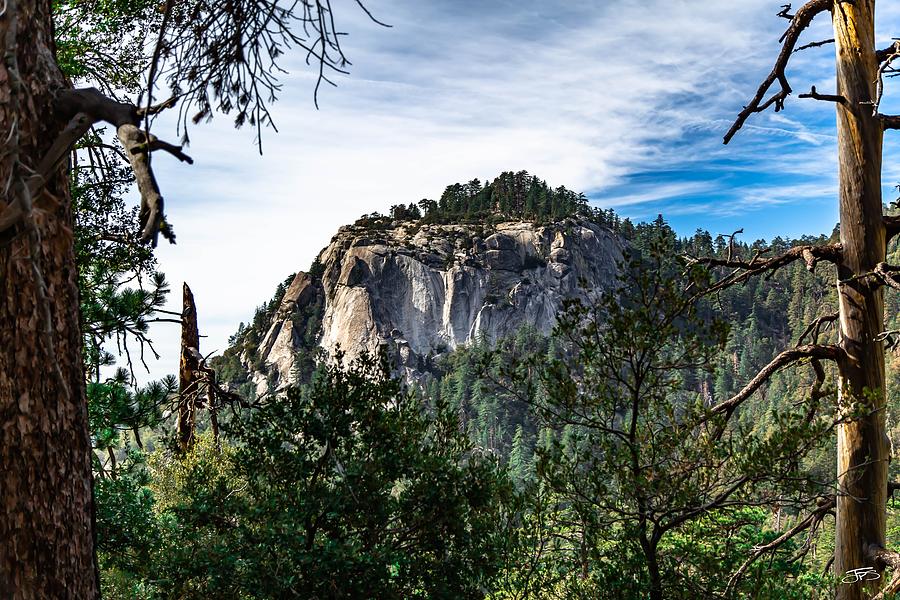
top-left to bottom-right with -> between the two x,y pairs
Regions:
0,0 -> 99,599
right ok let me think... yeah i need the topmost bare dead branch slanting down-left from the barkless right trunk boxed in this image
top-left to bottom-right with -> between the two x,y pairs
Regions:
724,0 -> 834,144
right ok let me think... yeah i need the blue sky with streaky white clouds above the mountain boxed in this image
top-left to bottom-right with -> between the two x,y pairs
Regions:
137,0 -> 900,381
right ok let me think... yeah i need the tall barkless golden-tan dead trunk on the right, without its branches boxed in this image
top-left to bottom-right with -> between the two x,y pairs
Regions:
832,0 -> 890,600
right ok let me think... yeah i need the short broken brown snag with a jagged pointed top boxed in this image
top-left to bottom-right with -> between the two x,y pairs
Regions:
178,283 -> 200,452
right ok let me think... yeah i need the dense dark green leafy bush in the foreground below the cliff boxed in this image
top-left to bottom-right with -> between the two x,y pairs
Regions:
98,359 -> 512,599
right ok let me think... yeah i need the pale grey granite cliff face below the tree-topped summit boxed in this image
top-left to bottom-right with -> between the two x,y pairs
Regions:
246,219 -> 623,391
